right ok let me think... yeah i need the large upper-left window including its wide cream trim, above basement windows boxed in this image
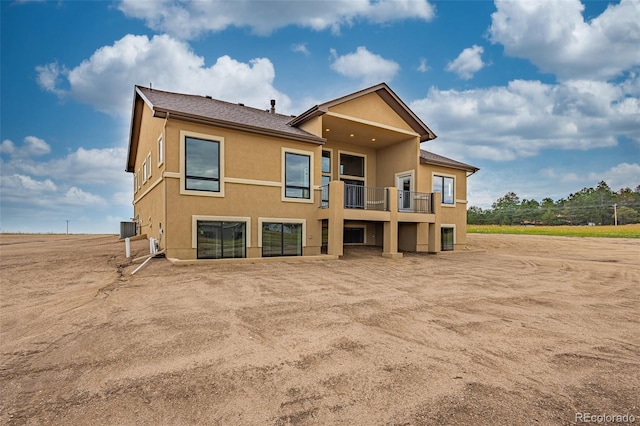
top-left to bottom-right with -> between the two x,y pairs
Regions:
180,130 -> 224,197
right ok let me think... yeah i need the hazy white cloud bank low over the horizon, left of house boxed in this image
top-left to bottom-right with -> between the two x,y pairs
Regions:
0,143 -> 132,233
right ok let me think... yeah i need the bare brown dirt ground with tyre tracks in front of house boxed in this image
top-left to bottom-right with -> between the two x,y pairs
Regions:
0,235 -> 640,425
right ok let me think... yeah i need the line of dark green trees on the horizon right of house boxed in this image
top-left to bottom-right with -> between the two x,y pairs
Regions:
467,181 -> 640,225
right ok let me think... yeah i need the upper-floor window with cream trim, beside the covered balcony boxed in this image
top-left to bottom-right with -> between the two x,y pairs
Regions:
282,148 -> 313,203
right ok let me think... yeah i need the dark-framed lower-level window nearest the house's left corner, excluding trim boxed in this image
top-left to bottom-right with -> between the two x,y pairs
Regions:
197,220 -> 247,259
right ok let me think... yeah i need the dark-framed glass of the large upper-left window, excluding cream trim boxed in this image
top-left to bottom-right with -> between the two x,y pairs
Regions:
184,136 -> 220,192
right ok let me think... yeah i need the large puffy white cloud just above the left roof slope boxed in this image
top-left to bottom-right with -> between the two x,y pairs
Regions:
37,33 -> 291,118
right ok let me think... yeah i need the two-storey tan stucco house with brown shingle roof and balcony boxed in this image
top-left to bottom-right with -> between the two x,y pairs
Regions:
126,83 -> 478,259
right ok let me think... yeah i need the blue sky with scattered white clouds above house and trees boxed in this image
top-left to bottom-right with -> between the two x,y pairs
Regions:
0,0 -> 640,233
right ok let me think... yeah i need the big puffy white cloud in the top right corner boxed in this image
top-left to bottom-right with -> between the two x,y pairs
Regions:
489,0 -> 640,80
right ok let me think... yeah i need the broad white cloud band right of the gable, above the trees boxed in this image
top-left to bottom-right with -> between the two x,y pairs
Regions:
410,76 -> 640,161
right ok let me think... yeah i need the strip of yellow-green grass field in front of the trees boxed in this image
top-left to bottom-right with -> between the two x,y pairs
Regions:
467,224 -> 640,238
